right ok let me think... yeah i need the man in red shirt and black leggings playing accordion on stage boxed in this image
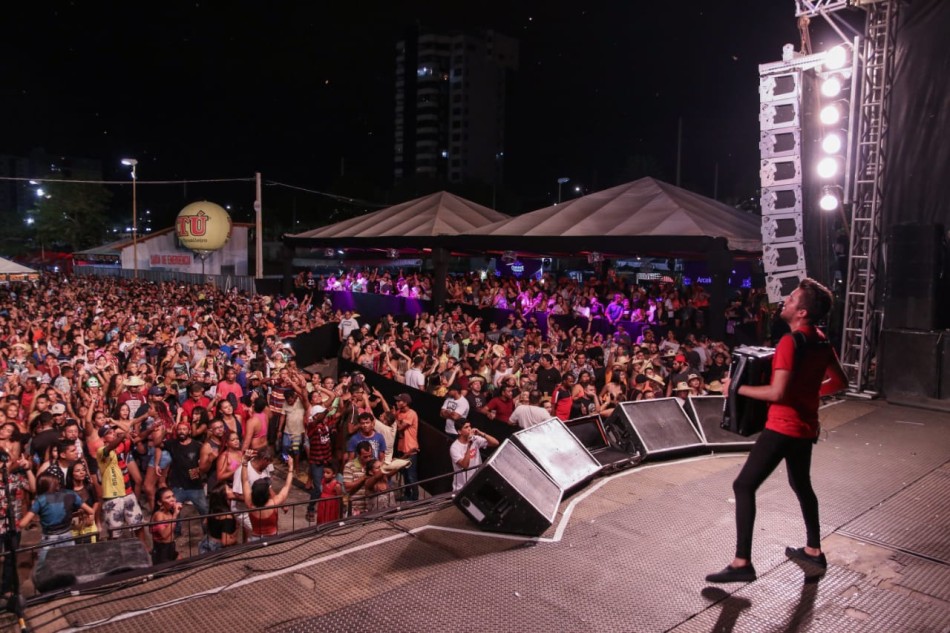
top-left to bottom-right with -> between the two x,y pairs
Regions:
706,278 -> 848,582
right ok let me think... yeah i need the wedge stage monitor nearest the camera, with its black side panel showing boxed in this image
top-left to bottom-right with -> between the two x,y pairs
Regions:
455,440 -> 562,536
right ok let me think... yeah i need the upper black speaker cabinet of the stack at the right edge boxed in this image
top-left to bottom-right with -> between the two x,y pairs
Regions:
884,223 -> 948,330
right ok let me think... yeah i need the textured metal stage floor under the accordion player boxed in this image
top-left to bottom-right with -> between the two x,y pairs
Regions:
13,401 -> 950,633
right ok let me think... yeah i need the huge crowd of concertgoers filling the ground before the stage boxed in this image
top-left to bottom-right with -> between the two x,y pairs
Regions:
0,272 -> 768,591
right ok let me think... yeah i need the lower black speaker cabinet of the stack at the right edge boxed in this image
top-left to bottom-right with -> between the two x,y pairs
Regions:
883,329 -> 946,405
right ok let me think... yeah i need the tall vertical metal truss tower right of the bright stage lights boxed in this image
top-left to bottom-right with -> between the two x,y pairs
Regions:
841,0 -> 899,394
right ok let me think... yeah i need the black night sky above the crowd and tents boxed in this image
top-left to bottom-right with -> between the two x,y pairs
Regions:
0,0 -> 856,225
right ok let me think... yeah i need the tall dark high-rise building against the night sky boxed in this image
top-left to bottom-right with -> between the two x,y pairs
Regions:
393,28 -> 518,184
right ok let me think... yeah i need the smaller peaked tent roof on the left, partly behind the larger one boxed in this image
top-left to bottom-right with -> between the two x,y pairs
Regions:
285,191 -> 509,247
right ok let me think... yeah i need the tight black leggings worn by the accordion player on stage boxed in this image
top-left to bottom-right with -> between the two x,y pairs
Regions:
732,429 -> 821,559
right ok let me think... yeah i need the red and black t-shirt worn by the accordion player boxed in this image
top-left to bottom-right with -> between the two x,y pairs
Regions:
765,325 -> 835,439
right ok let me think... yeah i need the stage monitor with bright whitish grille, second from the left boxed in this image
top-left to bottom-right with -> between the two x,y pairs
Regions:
510,418 -> 600,493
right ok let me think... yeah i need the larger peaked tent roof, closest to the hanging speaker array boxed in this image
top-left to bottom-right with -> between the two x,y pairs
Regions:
459,178 -> 762,252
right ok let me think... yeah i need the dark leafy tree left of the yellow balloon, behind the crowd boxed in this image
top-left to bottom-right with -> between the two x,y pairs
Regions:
36,181 -> 112,250
